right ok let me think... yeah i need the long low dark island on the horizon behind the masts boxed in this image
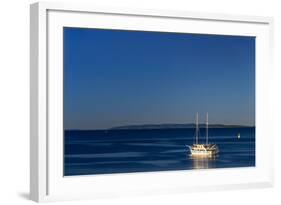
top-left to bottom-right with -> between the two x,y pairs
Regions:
109,123 -> 254,130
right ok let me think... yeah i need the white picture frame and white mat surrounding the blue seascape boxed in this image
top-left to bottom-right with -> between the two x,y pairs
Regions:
30,2 -> 273,202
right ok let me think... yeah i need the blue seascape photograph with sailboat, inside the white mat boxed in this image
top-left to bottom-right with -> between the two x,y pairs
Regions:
63,27 -> 256,176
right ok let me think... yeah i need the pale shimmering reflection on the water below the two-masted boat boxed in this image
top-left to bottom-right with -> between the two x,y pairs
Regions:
189,155 -> 218,169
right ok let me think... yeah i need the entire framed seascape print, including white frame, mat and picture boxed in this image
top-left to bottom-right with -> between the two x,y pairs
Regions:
30,3 -> 273,201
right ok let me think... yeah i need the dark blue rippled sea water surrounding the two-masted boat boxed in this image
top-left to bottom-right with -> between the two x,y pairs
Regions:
64,128 -> 255,176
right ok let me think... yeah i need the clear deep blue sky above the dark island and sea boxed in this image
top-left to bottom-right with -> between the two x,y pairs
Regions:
64,28 -> 255,129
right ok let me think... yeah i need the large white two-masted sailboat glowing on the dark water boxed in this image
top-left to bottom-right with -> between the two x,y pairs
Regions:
187,113 -> 219,158
